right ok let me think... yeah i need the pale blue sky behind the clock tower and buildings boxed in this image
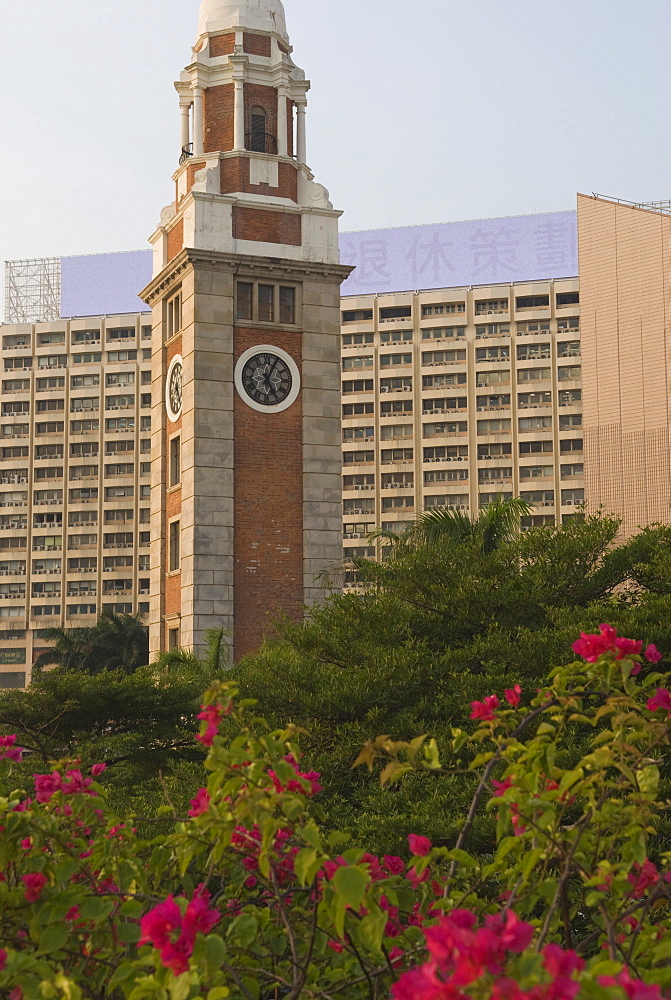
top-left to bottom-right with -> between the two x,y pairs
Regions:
0,0 -> 671,308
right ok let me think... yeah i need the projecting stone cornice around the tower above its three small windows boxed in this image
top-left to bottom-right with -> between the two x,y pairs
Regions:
140,249 -> 354,305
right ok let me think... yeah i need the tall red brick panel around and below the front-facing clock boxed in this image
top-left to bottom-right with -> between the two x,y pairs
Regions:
233,327 -> 303,660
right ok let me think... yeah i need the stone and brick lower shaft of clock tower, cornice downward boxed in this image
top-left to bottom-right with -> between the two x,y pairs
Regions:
143,250 -> 350,659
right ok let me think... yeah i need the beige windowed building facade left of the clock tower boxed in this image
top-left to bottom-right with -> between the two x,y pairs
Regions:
0,313 -> 151,687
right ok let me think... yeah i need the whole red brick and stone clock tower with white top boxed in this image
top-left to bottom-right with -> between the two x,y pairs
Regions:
142,0 -> 351,659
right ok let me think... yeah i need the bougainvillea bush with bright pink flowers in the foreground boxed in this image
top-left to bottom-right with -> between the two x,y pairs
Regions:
0,626 -> 671,1000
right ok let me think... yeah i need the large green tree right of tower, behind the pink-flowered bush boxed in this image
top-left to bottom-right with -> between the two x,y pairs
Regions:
233,516 -> 671,850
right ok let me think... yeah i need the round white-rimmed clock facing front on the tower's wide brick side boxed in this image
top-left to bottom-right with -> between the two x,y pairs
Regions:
235,344 -> 300,413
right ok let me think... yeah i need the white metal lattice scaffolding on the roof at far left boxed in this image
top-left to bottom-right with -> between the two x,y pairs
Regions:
5,257 -> 61,323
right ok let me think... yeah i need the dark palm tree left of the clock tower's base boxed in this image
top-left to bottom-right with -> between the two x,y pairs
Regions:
34,611 -> 149,674
